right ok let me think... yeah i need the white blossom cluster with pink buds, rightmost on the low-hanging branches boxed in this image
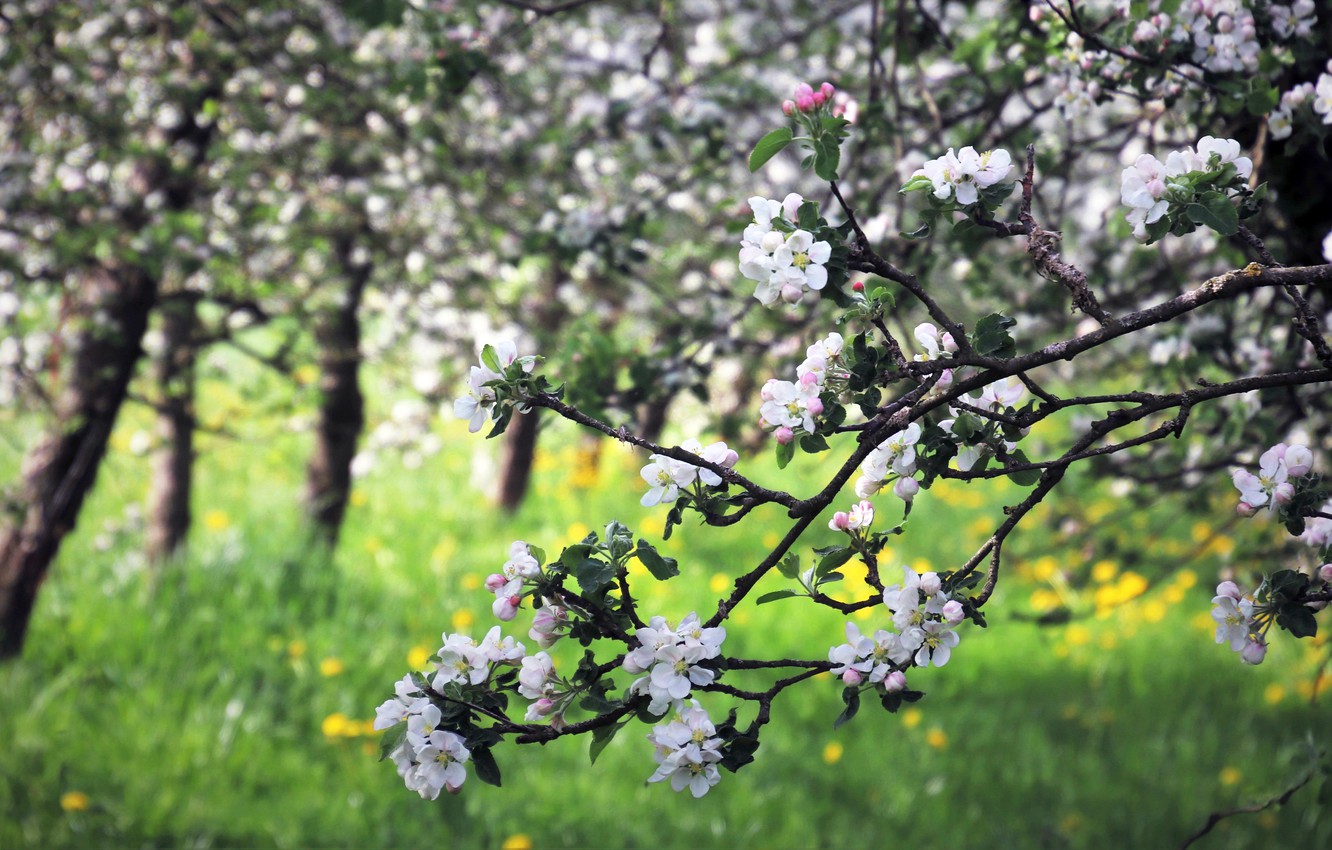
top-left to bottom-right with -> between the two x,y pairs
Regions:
829,566 -> 966,693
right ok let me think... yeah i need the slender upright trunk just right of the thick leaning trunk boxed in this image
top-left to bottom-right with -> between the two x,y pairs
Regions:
147,292 -> 198,564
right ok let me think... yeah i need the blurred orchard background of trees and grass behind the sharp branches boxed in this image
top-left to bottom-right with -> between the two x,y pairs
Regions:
0,0 -> 1332,850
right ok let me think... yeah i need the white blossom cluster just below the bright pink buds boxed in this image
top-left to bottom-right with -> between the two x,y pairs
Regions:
739,192 -> 833,306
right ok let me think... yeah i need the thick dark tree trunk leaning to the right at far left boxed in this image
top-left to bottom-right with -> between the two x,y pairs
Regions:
0,265 -> 157,658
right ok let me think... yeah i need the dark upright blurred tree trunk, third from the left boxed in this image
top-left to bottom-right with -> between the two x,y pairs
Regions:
305,255 -> 370,548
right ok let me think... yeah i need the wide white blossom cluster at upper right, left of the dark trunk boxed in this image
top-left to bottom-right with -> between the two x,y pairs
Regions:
1119,136 -> 1253,242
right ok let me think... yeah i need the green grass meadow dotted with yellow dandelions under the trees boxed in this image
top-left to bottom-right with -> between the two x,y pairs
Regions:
0,394 -> 1332,850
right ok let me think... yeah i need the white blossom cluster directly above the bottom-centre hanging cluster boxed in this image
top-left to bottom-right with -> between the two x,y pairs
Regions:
621,612 -> 726,717
